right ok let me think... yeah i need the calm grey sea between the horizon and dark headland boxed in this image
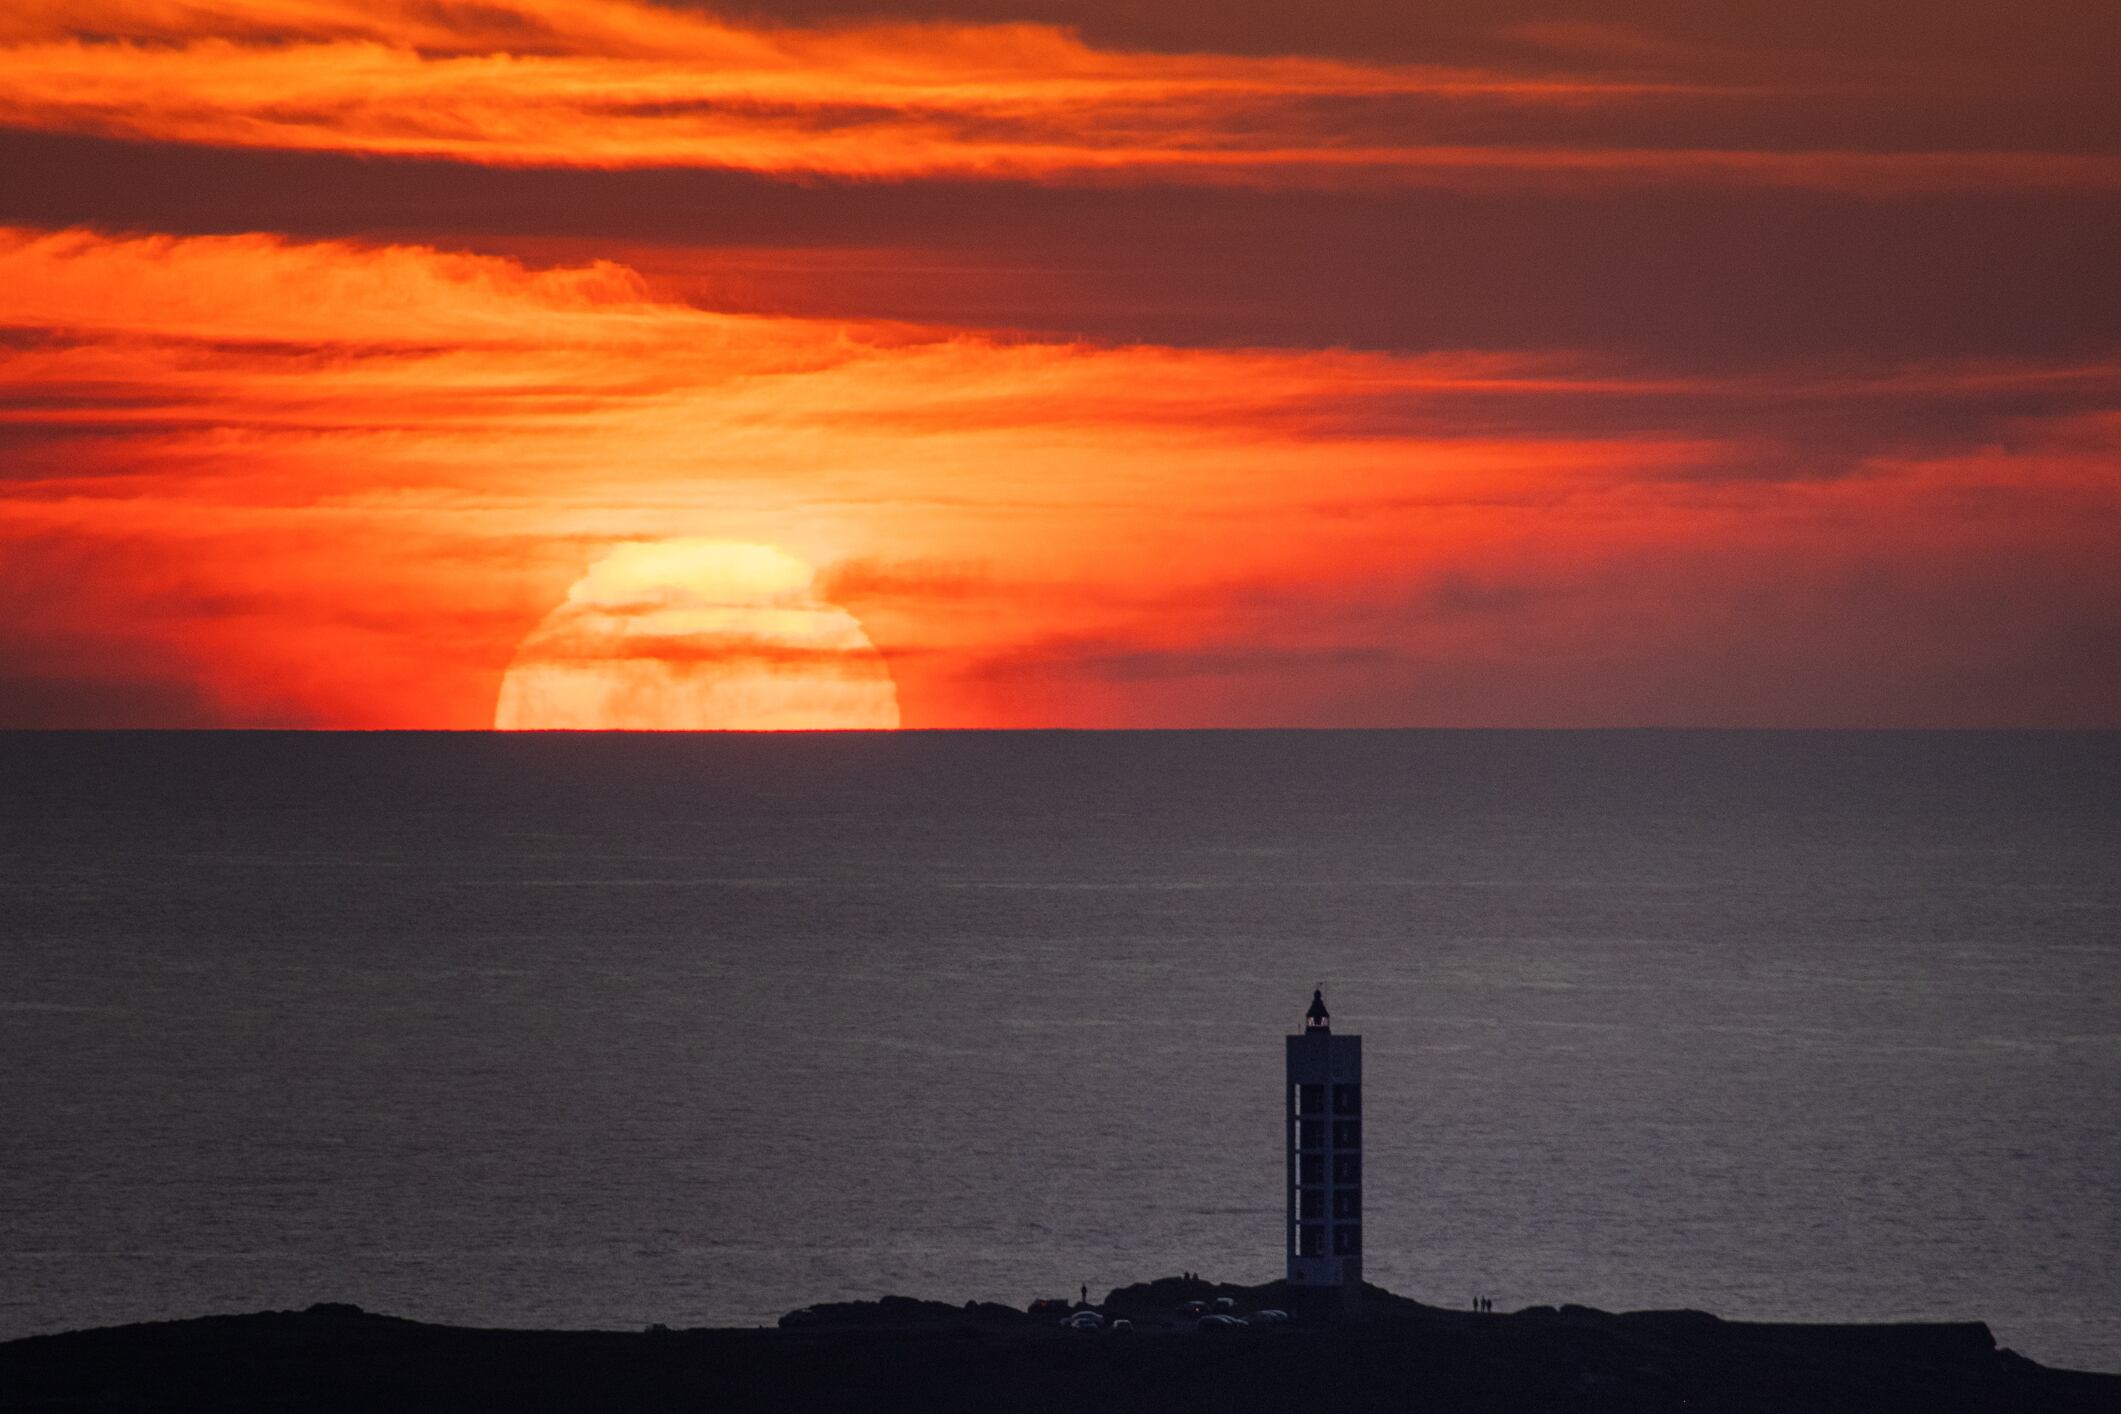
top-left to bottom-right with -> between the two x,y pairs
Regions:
0,731 -> 2121,1369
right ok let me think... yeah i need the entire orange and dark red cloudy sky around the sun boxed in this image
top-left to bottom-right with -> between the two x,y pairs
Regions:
0,0 -> 2121,727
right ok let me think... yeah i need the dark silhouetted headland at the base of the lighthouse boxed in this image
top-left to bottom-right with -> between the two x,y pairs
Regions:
0,1280 -> 2121,1414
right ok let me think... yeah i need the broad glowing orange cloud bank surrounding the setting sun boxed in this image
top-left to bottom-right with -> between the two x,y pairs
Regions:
0,231 -> 2121,727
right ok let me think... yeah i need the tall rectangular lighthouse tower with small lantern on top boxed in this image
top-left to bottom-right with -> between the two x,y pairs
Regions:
1287,988 -> 1362,1295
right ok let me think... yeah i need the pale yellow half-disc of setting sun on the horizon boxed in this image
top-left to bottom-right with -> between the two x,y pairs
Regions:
494,538 -> 899,731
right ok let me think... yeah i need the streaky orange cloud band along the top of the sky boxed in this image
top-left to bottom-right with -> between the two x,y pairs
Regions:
0,0 -> 2121,193
